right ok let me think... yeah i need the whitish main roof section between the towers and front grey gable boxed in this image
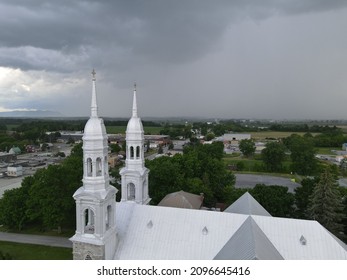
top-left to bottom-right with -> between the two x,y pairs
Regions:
114,202 -> 247,260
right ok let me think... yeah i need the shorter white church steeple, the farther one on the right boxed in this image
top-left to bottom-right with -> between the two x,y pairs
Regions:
120,83 -> 150,204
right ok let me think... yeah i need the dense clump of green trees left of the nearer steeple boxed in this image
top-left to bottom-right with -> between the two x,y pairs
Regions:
0,144 -> 83,230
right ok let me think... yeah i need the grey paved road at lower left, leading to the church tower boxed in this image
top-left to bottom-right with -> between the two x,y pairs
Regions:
0,232 -> 72,248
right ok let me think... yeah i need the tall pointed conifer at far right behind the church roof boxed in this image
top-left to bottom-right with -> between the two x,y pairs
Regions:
308,168 -> 344,235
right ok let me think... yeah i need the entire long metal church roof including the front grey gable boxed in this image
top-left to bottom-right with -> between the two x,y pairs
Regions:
114,202 -> 347,260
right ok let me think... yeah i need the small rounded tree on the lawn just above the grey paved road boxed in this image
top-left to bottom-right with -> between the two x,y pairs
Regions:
261,142 -> 286,172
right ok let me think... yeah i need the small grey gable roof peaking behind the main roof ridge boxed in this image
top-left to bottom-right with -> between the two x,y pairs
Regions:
224,192 -> 271,217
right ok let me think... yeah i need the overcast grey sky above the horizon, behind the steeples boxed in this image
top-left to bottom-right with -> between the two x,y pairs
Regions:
0,0 -> 347,119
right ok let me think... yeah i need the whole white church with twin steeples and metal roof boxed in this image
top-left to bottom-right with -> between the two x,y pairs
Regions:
70,71 -> 347,260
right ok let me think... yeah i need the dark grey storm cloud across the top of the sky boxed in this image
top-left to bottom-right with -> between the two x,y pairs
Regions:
0,0 -> 347,71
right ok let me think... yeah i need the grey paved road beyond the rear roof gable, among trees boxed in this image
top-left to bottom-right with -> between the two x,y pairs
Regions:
235,174 -> 300,193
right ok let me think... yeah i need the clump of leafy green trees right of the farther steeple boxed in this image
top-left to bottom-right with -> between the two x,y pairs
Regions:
146,143 -> 235,207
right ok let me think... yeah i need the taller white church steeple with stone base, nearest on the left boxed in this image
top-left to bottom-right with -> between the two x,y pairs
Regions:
70,70 -> 117,259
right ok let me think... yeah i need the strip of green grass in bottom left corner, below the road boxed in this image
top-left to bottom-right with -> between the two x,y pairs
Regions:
0,241 -> 72,260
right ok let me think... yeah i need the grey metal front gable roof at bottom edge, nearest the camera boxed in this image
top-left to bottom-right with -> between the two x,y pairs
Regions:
214,216 -> 284,260
